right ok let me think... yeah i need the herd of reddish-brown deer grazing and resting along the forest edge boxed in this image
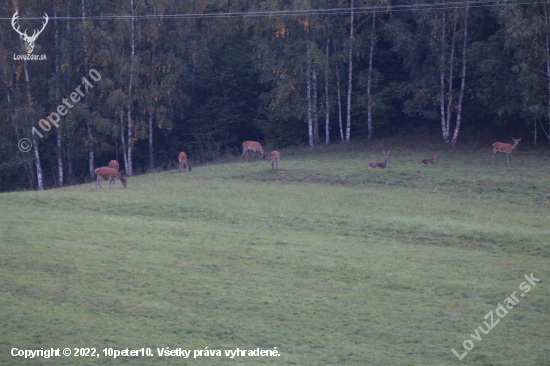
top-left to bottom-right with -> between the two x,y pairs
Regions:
95,138 -> 521,189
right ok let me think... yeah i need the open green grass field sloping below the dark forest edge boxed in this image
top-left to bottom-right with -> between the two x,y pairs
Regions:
0,142 -> 550,366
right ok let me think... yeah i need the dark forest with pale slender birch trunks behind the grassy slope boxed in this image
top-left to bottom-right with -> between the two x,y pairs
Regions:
0,0 -> 550,191
